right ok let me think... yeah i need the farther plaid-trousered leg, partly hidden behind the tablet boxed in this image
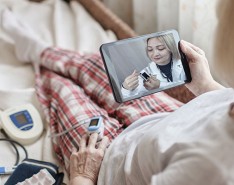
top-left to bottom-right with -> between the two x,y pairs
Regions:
41,48 -> 182,127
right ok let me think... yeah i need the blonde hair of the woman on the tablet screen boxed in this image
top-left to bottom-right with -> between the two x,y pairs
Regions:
146,34 -> 180,60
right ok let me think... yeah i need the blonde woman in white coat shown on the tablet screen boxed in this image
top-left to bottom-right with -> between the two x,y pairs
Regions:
121,34 -> 186,98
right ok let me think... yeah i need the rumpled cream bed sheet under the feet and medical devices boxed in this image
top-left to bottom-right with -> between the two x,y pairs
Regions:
0,0 -> 116,184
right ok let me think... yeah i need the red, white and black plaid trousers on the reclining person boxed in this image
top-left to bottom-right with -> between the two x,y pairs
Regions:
36,48 -> 182,170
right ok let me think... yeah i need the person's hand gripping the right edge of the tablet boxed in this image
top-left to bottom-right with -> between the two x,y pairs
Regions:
180,41 -> 224,96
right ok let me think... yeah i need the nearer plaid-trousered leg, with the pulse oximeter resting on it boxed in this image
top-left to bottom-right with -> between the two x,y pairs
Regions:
36,69 -> 122,168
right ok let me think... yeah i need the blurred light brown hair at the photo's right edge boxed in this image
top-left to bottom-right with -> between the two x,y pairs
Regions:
212,0 -> 234,87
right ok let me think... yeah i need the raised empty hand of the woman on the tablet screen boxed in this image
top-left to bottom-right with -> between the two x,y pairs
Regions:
123,70 -> 139,91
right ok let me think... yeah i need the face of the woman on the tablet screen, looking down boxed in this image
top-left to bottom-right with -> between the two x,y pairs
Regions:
147,37 -> 171,65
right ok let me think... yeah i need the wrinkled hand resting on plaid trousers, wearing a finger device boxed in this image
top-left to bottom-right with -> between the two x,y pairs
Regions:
70,133 -> 109,185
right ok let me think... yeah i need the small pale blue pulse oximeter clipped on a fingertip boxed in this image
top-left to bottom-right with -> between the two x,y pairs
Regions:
88,116 -> 104,140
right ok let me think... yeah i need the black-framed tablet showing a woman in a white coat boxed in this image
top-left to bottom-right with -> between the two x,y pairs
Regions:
100,30 -> 191,103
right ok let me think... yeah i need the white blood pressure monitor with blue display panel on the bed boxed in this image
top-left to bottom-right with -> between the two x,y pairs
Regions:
0,104 -> 43,144
